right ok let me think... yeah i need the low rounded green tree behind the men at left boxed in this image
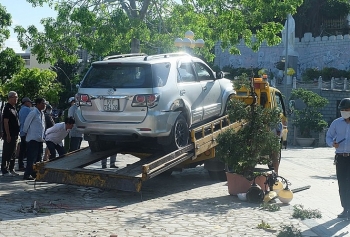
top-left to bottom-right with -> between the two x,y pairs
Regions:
3,68 -> 62,104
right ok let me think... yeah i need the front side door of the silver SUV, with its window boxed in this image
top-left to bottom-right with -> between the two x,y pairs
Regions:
194,62 -> 222,119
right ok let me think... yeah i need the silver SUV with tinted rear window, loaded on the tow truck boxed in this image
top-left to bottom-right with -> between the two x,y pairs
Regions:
75,53 -> 235,152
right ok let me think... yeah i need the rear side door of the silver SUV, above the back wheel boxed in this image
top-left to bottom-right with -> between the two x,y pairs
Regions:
177,61 -> 203,124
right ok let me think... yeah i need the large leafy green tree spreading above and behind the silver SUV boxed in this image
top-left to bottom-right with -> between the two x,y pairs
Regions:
15,0 -> 303,64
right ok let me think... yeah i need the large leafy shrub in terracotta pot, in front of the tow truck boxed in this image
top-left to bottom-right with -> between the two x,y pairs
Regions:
216,75 -> 280,195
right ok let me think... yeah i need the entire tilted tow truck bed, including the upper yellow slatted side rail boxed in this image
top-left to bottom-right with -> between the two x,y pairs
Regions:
34,116 -> 246,192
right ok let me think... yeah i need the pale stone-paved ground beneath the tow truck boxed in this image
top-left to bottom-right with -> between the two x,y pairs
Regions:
0,142 -> 350,237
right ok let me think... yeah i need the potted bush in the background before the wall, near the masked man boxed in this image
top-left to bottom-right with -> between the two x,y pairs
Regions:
291,88 -> 328,146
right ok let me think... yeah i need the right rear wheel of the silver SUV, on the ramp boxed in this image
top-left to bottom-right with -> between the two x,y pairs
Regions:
162,114 -> 190,151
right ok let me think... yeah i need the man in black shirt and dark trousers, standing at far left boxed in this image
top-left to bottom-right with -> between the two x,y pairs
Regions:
1,91 -> 20,176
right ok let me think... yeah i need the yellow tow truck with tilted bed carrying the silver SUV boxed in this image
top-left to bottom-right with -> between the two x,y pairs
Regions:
34,78 -> 286,192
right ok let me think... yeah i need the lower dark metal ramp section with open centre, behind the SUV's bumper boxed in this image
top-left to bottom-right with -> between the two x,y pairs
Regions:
34,144 -> 194,192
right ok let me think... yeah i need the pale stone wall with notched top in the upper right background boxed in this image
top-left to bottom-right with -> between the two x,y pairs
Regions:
214,33 -> 350,79
